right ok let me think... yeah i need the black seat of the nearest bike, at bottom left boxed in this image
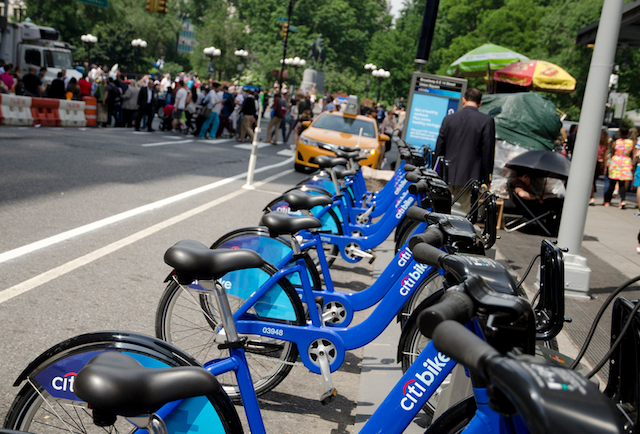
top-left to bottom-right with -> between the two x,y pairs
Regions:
73,351 -> 221,417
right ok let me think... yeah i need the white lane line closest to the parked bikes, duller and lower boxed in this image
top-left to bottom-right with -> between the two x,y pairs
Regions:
0,169 -> 293,304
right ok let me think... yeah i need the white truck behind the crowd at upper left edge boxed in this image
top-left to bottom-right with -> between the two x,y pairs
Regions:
0,22 -> 82,84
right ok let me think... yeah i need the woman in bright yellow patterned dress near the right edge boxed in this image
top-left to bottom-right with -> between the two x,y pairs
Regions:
604,126 -> 634,209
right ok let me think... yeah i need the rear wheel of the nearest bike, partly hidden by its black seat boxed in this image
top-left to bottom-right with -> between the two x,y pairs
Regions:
4,334 -> 242,434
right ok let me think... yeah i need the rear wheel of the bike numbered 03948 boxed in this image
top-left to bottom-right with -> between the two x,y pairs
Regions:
156,264 -> 306,403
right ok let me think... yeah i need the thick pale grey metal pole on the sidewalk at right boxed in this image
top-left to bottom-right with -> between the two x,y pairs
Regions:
558,0 -> 624,298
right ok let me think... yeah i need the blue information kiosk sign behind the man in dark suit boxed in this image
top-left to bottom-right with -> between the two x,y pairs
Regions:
403,72 -> 467,150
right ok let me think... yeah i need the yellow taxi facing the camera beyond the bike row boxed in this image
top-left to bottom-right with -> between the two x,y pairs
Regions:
294,97 -> 389,172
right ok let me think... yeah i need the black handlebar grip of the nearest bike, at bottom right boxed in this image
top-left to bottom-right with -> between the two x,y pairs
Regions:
430,321 -> 500,376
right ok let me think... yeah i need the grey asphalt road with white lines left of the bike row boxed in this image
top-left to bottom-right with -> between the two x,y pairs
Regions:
0,126 -> 382,433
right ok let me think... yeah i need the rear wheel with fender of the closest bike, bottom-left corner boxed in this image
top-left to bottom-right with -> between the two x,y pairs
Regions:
3,332 -> 242,434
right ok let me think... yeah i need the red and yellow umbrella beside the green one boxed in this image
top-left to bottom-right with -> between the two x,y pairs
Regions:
493,60 -> 576,93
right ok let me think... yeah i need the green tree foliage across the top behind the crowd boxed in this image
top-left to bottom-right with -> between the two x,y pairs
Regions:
20,0 -> 640,119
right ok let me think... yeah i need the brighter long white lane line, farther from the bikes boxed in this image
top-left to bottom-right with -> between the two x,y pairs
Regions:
0,159 -> 293,264
